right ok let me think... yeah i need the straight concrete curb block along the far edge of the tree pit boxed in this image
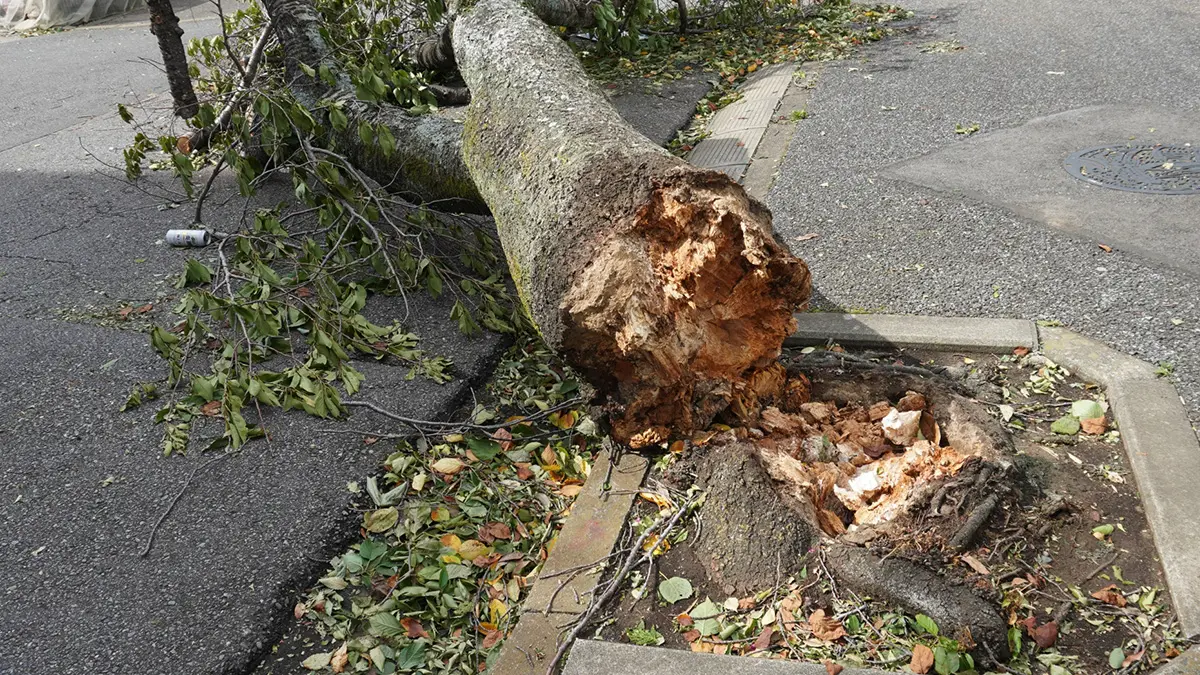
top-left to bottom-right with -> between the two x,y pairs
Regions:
784,312 -> 1038,352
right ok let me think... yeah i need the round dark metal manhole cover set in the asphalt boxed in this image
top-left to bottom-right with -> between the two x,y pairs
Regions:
1063,143 -> 1200,195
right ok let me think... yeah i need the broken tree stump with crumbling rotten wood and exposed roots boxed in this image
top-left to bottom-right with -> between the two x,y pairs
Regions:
677,366 -> 1018,655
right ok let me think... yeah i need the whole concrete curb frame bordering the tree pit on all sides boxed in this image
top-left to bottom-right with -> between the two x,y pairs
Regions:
491,312 -> 1200,675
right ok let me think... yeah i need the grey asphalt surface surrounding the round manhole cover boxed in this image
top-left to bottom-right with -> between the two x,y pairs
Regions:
768,0 -> 1200,422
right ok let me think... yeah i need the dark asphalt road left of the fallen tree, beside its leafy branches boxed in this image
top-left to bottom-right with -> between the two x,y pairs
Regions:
0,8 -> 503,675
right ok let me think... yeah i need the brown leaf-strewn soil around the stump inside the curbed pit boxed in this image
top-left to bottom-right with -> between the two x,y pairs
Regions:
585,343 -> 1187,675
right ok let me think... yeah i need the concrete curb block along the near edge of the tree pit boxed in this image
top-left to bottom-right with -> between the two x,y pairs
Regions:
563,640 -> 884,675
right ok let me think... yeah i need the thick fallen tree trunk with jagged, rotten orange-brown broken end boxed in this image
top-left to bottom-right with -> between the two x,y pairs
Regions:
454,0 -> 810,447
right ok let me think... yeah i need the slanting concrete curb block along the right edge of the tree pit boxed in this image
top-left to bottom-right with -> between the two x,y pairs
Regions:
1109,380 -> 1200,637
